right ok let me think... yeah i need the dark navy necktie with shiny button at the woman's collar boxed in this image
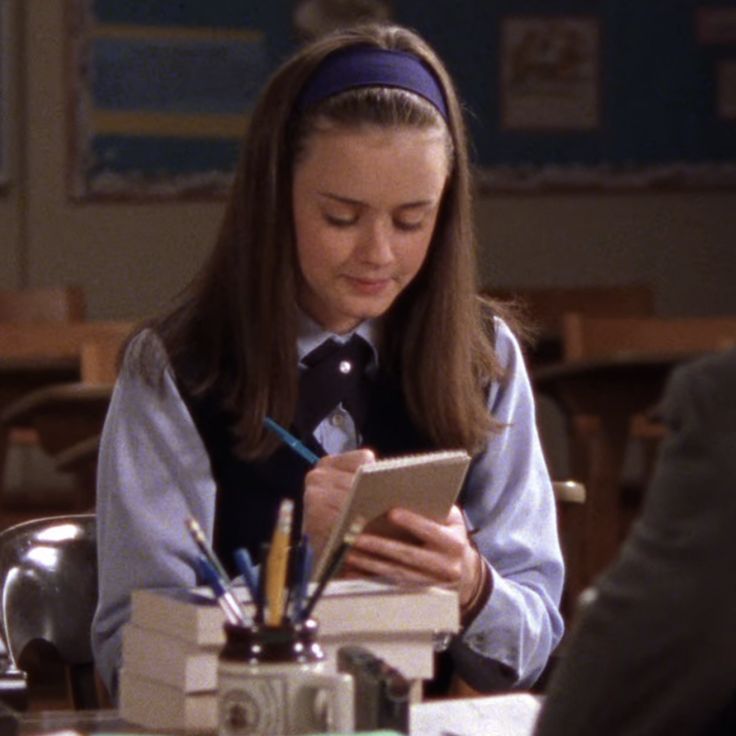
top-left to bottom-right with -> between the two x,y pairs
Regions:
294,335 -> 373,436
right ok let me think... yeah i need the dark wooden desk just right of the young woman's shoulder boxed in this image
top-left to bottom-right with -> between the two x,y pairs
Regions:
532,353 -> 694,598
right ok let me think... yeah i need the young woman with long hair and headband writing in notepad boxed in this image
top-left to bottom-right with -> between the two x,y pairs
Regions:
93,26 -> 563,692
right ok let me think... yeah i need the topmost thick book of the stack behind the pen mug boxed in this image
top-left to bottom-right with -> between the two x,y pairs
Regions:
130,579 -> 460,646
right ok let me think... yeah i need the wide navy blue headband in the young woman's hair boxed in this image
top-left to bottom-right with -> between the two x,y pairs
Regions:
296,46 -> 448,121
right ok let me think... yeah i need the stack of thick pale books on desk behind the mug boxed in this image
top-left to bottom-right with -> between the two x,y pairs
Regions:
120,580 -> 460,731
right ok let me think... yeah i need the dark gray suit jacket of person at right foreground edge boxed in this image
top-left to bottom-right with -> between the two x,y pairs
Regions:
535,350 -> 736,736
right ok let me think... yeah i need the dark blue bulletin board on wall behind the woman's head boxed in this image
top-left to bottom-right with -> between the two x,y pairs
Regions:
68,0 -> 736,200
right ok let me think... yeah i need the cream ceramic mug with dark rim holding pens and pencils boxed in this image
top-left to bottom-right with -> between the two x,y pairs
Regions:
218,621 -> 354,736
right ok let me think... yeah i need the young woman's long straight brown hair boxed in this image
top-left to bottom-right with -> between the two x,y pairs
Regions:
147,25 -> 500,458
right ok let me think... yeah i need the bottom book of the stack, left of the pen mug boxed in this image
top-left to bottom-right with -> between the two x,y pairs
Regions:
119,666 -> 217,731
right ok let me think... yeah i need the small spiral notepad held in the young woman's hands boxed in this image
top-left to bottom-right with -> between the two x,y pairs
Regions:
313,450 -> 470,580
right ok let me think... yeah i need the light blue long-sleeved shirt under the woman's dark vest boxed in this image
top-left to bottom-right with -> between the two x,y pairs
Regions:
92,317 -> 563,692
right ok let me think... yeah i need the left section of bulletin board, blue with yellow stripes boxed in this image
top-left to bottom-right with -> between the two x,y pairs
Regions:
68,0 -> 267,200
